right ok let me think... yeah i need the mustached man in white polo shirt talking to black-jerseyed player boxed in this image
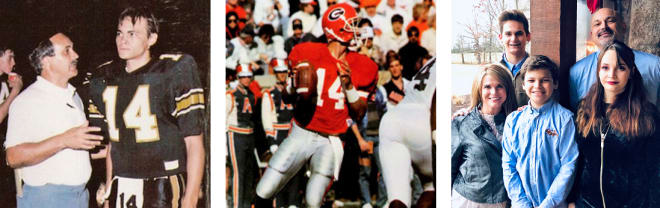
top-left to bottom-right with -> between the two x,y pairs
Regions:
5,33 -> 103,207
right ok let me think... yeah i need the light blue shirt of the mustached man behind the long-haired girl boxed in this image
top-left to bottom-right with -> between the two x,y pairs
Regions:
568,50 -> 660,111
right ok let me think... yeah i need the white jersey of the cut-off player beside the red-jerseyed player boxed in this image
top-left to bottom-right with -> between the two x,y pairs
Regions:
399,57 -> 435,109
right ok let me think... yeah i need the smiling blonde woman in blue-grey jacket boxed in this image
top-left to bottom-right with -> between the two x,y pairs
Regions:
451,64 -> 517,208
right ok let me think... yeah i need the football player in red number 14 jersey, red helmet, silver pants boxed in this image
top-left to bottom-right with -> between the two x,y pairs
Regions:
257,3 -> 378,207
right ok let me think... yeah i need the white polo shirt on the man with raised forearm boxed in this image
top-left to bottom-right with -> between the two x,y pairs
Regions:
5,76 -> 92,186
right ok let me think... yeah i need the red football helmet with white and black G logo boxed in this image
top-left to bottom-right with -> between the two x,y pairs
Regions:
321,3 -> 359,43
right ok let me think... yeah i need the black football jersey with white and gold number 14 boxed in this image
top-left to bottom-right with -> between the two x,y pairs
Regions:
88,54 -> 205,178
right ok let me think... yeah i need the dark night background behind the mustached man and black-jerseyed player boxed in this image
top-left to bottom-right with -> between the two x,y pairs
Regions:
0,0 -> 210,207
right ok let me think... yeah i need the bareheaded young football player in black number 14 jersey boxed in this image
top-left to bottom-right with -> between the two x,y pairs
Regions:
89,7 -> 205,207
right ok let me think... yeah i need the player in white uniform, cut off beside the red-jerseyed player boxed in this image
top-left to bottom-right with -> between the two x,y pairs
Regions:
379,58 -> 435,207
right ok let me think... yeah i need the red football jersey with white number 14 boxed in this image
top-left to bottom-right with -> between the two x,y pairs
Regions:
288,42 -> 378,134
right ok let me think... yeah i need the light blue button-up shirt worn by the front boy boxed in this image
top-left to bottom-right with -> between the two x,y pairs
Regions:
502,99 -> 578,207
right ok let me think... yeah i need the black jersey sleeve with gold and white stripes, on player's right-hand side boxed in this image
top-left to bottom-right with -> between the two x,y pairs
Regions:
160,54 -> 206,137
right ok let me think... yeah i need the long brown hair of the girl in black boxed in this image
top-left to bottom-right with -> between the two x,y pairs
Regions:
576,40 -> 656,139
